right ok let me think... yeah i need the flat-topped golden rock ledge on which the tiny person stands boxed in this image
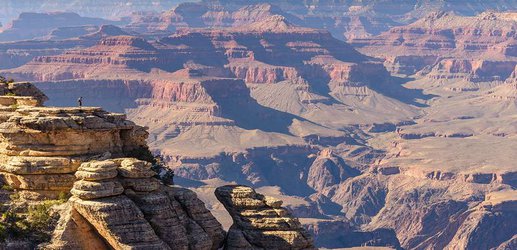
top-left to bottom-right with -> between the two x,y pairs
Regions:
0,83 -> 148,198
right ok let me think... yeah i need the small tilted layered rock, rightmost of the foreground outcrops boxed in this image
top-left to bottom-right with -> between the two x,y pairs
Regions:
215,185 -> 315,249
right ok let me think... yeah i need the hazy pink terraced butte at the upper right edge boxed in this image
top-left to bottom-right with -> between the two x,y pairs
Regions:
351,12 -> 517,77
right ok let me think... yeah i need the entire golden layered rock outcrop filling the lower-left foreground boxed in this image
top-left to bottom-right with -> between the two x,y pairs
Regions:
0,83 -> 314,249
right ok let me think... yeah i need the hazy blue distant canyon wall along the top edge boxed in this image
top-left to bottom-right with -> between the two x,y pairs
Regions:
127,0 -> 516,40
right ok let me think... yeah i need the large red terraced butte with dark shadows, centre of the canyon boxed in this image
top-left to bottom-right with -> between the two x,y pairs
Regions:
1,16 -> 417,160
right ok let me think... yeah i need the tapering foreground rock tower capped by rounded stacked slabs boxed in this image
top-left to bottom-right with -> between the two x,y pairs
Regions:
49,158 -> 225,250
